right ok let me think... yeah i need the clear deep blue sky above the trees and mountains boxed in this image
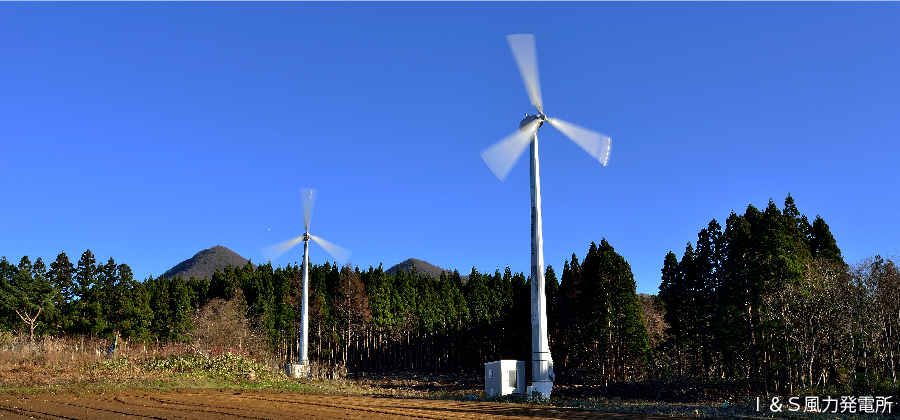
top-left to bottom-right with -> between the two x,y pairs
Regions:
0,2 -> 900,293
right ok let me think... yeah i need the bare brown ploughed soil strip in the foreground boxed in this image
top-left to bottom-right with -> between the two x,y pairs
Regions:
0,389 -> 647,420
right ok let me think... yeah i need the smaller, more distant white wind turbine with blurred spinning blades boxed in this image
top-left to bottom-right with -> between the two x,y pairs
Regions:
262,188 -> 350,372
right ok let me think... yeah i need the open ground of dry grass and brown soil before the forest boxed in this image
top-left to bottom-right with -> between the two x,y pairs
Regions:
0,333 -> 856,420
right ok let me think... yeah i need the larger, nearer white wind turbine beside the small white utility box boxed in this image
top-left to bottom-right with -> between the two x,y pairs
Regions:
481,34 -> 611,398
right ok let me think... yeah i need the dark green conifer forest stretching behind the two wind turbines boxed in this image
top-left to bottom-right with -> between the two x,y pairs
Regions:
0,196 -> 900,392
